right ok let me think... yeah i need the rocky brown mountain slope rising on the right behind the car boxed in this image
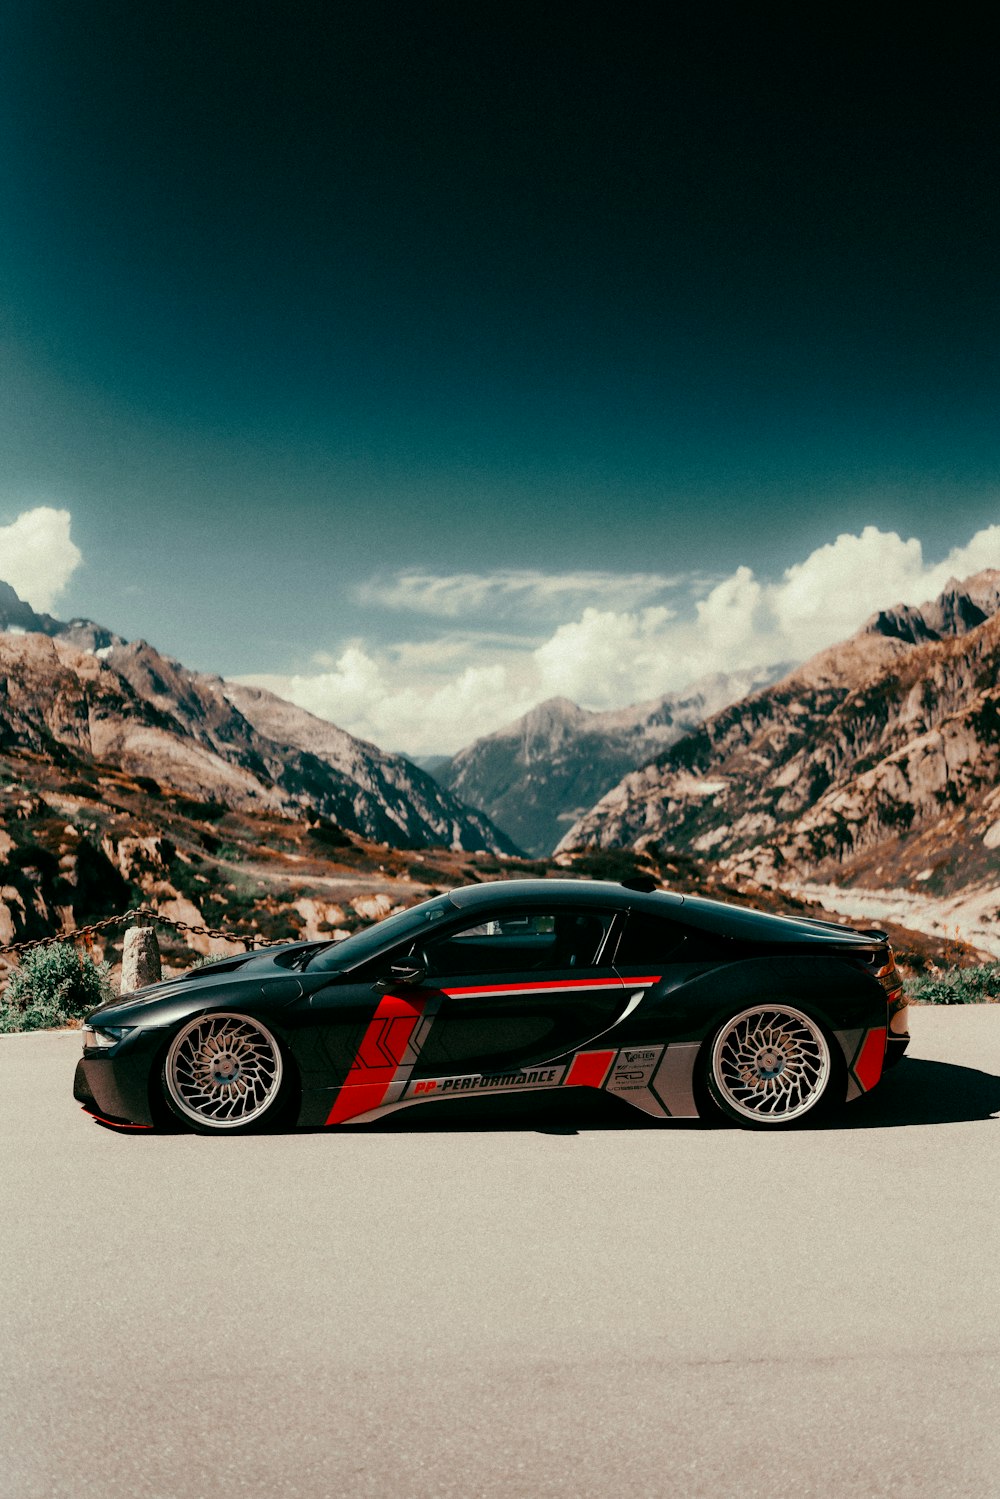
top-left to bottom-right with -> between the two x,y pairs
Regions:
561,571 -> 1000,892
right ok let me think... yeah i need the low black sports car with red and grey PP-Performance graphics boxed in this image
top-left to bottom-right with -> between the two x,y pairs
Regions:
73,880 -> 909,1132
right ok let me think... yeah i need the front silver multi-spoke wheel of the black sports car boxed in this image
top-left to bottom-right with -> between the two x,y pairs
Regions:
163,1012 -> 282,1129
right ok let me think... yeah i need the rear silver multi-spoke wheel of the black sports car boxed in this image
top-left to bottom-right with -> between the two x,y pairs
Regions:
712,1004 -> 831,1124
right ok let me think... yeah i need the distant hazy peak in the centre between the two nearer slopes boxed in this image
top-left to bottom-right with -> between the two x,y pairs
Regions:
429,667 -> 787,856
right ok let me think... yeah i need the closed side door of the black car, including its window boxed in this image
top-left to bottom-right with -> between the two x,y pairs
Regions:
414,908 -> 625,1079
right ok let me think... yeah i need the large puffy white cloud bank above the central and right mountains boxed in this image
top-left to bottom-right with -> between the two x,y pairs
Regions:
236,525 -> 1000,754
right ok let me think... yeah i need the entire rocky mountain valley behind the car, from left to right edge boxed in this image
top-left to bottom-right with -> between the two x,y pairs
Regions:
0,573 -> 1000,971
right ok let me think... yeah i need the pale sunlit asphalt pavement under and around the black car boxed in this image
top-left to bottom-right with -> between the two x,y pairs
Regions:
0,1006 -> 1000,1499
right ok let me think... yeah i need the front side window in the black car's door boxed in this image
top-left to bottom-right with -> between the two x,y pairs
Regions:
423,910 -> 613,974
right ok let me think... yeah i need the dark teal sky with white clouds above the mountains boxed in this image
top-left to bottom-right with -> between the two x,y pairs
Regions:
0,0 -> 1000,752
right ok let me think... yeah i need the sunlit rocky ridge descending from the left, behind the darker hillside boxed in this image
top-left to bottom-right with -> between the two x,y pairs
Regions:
0,589 -> 516,853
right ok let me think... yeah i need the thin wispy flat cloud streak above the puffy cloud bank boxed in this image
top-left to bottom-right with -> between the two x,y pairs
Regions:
357,568 -> 685,619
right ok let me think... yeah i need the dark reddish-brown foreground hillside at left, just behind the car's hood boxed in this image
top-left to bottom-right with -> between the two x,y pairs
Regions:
0,748 -> 544,971
